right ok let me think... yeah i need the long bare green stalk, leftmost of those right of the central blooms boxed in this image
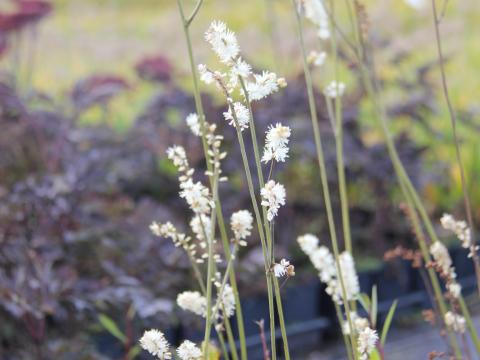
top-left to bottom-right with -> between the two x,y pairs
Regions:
292,0 -> 357,359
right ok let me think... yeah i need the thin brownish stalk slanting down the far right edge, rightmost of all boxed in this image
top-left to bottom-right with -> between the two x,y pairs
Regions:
432,0 -> 480,295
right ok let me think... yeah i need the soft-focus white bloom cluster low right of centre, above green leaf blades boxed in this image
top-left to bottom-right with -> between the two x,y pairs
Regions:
297,234 -> 360,304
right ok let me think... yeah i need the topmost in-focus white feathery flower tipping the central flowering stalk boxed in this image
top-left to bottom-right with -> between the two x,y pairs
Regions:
205,21 -> 240,64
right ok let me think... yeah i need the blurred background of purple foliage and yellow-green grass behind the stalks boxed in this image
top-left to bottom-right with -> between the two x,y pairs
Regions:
0,0 -> 480,359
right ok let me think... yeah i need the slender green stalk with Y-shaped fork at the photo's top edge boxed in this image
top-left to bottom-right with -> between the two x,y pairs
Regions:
177,0 -> 247,360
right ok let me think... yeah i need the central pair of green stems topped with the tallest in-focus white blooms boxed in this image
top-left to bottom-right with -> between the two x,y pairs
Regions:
198,21 -> 293,359
